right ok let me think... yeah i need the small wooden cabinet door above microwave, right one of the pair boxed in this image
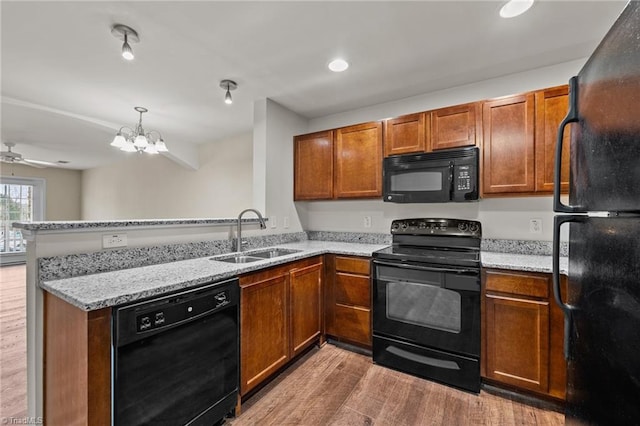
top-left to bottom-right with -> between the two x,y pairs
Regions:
431,103 -> 480,151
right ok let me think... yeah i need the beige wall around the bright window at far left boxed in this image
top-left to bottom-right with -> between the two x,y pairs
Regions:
0,163 -> 82,221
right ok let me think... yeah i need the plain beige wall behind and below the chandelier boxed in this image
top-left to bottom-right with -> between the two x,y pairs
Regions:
82,133 -> 253,220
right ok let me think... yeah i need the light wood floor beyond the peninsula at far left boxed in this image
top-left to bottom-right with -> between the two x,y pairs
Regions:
0,265 -> 27,419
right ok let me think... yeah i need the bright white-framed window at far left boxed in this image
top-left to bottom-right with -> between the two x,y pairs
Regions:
0,176 -> 45,265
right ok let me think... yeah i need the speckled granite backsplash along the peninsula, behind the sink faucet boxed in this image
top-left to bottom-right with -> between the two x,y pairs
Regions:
38,232 -> 307,281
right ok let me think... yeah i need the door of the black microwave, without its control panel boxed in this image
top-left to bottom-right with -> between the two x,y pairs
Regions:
382,156 -> 453,203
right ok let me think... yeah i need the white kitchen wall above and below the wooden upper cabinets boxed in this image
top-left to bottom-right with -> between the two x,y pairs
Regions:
296,59 -> 586,240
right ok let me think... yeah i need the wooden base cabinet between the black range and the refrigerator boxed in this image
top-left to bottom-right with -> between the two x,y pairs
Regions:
482,269 -> 566,399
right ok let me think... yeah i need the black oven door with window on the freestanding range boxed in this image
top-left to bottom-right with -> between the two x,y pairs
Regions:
373,260 -> 480,357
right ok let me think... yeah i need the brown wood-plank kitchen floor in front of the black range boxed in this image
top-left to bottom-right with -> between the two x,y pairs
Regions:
230,344 -> 564,426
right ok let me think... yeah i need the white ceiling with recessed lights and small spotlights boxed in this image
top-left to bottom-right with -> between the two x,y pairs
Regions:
0,0 -> 626,169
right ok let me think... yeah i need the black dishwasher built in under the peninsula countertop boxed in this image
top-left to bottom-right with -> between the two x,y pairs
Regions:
112,279 -> 240,426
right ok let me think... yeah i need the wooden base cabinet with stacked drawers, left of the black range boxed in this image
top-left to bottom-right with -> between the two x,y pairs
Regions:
325,255 -> 371,348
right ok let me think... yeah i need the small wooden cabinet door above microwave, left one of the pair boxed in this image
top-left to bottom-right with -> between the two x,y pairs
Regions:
384,112 -> 430,157
